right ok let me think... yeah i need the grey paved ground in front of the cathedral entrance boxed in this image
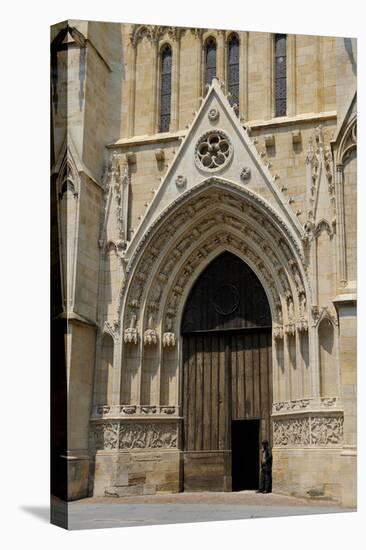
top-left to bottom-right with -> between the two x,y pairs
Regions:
63,491 -> 354,529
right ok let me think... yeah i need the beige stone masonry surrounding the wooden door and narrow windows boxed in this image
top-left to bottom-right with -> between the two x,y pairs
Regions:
52,21 -> 356,504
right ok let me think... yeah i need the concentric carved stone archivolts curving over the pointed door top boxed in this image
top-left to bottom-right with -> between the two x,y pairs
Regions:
120,184 -> 307,345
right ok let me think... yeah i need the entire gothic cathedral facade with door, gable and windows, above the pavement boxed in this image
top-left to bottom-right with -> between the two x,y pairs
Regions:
51,21 -> 357,506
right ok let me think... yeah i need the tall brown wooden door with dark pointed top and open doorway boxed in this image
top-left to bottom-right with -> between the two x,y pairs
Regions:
182,253 -> 272,491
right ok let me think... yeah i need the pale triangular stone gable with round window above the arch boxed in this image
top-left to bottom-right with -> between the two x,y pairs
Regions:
129,78 -> 302,256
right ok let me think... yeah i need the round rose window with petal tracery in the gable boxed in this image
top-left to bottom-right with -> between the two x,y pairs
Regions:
195,130 -> 232,171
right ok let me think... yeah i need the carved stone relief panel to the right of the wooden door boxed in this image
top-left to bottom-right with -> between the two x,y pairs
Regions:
273,414 -> 343,447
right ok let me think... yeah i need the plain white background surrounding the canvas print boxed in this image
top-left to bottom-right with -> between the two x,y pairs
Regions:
0,0 -> 366,550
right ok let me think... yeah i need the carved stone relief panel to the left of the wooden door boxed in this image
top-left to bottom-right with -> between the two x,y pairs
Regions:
90,421 -> 178,451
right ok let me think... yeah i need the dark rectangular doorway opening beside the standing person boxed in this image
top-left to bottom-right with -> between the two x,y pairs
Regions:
231,419 -> 260,491
